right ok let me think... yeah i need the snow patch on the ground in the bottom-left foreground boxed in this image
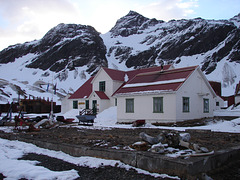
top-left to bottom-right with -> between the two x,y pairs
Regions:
0,138 -> 174,180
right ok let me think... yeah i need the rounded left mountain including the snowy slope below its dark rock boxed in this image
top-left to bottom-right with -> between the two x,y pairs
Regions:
0,24 -> 107,102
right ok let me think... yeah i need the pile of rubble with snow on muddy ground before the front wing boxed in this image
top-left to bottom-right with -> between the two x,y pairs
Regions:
130,131 -> 214,157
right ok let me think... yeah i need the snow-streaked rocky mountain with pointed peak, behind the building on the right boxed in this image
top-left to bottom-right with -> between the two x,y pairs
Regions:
107,11 -> 240,74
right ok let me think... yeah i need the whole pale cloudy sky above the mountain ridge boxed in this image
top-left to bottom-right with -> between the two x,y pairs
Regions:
0,0 -> 240,50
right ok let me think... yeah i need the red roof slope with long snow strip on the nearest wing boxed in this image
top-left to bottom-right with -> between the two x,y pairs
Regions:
115,66 -> 198,94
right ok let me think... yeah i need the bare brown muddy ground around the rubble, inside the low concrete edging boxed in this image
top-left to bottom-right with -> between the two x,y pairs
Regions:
4,126 -> 240,151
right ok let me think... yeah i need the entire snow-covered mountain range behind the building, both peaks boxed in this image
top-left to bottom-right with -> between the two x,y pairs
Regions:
0,11 -> 240,102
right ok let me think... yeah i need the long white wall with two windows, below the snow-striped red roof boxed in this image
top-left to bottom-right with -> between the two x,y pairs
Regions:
117,94 -> 176,123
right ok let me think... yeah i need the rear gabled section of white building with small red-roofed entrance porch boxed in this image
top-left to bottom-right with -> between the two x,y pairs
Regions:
62,65 -> 172,113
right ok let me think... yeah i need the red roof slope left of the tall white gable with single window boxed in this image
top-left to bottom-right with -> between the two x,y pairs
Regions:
68,76 -> 94,99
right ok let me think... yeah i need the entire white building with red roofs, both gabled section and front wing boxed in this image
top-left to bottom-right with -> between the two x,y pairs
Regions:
62,65 -> 223,123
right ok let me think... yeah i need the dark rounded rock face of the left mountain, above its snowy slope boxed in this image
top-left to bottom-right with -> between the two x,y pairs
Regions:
0,24 -> 107,73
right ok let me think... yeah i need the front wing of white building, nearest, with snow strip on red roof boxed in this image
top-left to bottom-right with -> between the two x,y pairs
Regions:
114,66 -> 217,123
